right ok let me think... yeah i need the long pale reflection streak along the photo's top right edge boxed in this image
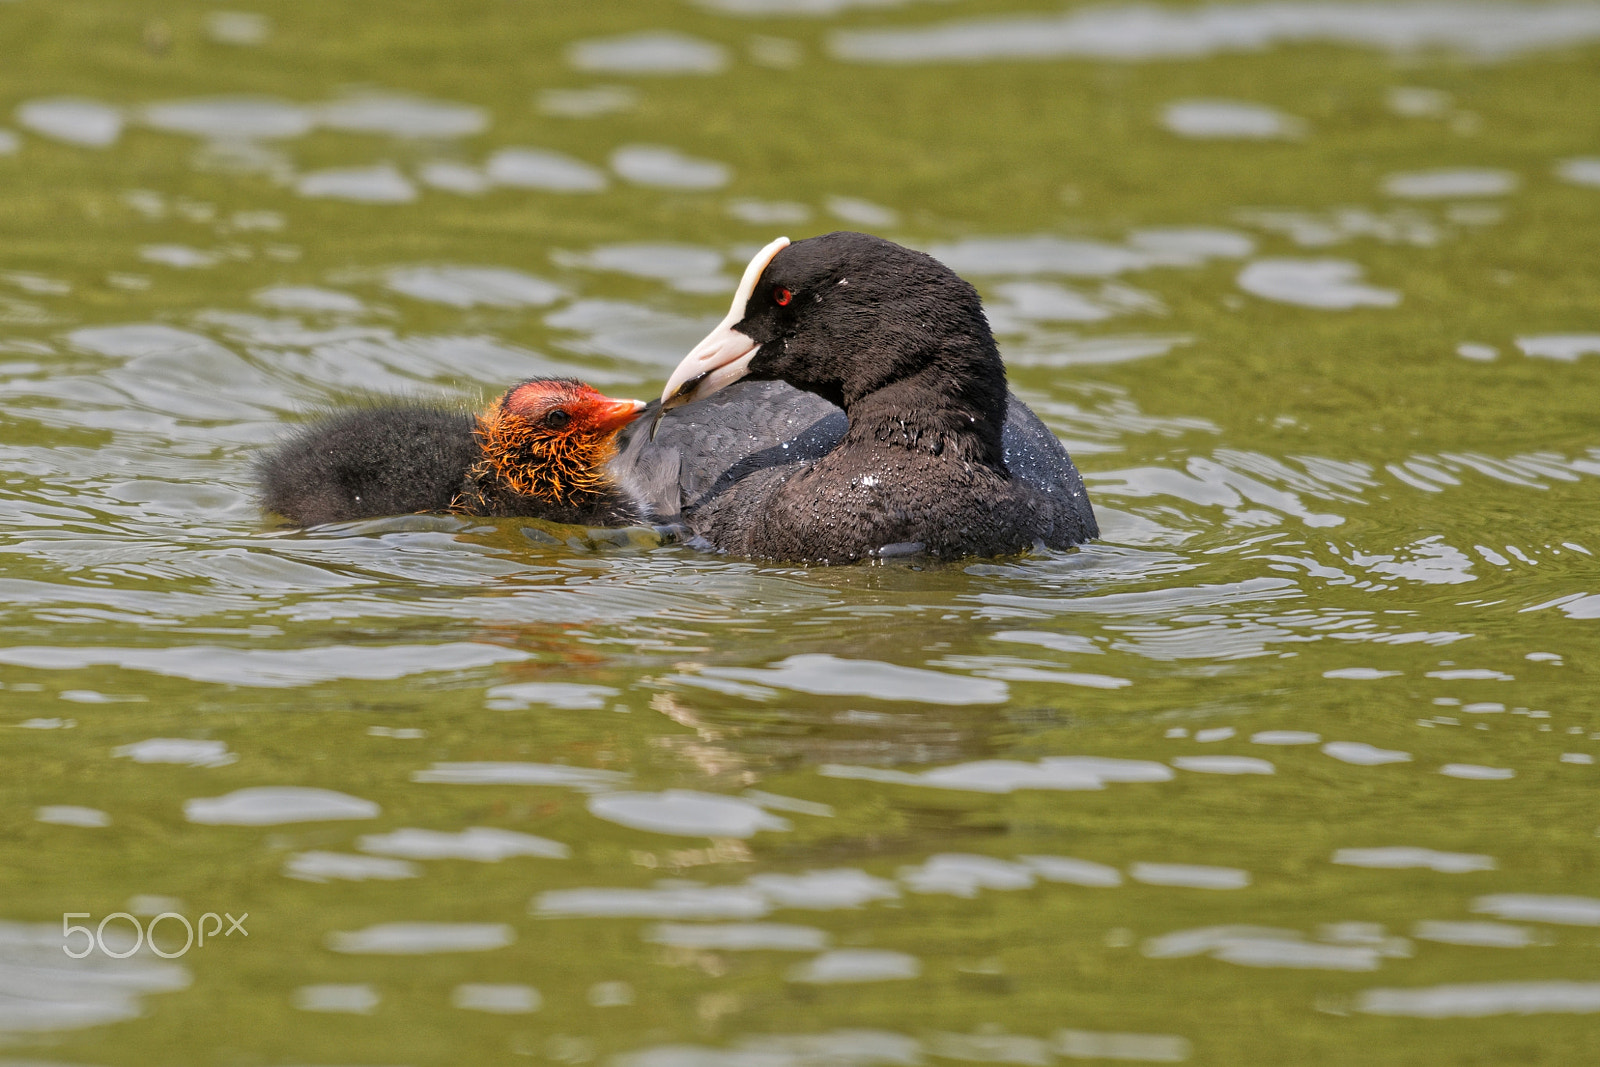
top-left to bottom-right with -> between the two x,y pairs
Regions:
829,0 -> 1600,64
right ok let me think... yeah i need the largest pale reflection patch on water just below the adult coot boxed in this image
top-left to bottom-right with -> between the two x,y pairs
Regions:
697,653 -> 1011,705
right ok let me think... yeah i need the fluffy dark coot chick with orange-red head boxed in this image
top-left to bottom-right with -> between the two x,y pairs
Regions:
254,378 -> 648,526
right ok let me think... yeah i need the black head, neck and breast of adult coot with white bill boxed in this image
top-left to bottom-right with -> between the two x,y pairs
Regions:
658,232 -> 1099,563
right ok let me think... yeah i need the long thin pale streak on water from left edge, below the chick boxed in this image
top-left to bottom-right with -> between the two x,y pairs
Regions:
0,643 -> 528,689
